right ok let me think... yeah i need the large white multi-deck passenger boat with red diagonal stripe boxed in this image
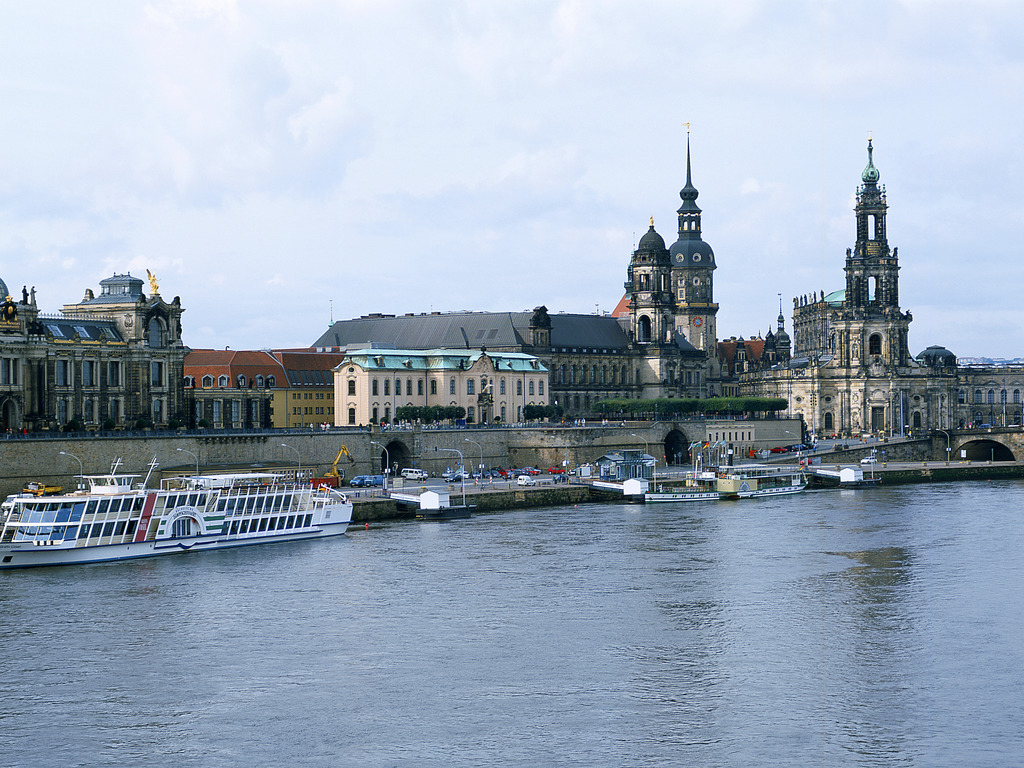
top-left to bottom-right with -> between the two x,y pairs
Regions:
0,463 -> 352,568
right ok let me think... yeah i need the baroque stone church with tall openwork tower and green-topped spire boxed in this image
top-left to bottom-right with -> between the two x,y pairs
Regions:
739,139 -> 966,434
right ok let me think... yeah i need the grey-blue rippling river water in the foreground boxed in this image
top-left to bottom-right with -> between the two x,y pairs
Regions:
0,481 -> 1024,768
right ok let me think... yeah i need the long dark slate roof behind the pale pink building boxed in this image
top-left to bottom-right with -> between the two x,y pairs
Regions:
311,311 -> 628,350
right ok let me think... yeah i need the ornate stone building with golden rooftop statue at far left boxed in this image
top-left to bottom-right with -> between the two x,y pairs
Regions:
0,273 -> 185,432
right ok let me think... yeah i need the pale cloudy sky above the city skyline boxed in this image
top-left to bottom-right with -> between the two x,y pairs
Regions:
0,0 -> 1024,357
